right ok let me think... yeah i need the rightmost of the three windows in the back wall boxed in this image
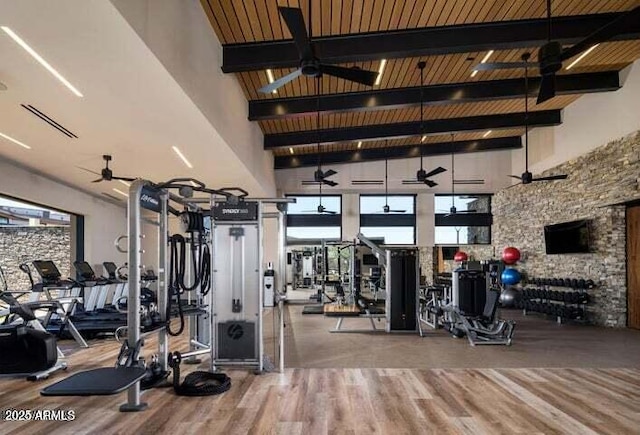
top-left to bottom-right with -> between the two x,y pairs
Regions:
434,195 -> 492,245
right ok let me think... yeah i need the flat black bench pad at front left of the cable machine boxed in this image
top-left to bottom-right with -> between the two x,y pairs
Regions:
40,367 -> 146,396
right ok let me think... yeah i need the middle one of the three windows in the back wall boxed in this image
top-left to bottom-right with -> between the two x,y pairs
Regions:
360,195 -> 416,245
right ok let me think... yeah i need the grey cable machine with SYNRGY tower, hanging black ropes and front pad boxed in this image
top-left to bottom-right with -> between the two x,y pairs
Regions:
41,178 -> 295,412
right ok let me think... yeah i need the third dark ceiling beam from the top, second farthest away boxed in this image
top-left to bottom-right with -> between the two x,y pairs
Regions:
264,110 -> 562,149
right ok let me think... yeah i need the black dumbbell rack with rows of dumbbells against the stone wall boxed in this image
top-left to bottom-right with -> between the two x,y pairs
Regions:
517,278 -> 595,323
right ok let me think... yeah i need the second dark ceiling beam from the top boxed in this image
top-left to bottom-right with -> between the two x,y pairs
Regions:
249,71 -> 620,121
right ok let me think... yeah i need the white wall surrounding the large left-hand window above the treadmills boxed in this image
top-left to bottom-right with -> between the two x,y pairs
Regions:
0,158 -> 127,265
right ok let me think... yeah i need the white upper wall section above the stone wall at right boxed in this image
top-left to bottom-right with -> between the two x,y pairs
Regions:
512,60 -> 640,174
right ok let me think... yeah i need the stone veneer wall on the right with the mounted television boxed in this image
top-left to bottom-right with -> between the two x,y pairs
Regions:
492,131 -> 640,327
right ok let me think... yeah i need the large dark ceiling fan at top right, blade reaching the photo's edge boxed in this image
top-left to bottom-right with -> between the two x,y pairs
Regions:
473,0 -> 640,104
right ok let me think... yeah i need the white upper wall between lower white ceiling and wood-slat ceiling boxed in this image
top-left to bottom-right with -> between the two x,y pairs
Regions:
112,0 -> 276,196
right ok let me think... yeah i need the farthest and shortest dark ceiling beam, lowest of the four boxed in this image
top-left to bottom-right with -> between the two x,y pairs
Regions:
274,136 -> 522,169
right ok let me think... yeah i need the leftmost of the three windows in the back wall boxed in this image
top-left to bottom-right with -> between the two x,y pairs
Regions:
287,195 -> 342,245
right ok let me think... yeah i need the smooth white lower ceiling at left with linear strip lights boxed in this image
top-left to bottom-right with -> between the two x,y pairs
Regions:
0,0 -> 272,204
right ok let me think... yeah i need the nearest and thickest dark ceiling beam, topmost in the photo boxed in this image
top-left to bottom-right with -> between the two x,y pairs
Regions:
222,13 -> 640,73
